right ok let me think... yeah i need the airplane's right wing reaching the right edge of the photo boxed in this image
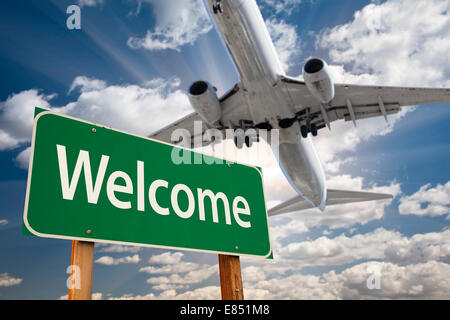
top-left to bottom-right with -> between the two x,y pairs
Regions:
280,76 -> 450,129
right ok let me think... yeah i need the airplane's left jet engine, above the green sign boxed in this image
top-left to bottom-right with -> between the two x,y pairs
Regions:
189,81 -> 222,125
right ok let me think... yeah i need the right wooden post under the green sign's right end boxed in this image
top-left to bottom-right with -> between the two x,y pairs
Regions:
219,254 -> 244,300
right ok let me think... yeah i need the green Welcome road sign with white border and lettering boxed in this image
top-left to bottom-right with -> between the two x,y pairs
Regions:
24,111 -> 271,257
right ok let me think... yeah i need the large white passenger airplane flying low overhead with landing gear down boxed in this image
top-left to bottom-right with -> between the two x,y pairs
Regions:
149,0 -> 450,216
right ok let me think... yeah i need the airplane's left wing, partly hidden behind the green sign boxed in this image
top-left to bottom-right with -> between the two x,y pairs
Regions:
148,84 -> 251,148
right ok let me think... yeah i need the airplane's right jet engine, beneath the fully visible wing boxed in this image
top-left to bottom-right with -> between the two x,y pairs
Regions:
303,58 -> 334,104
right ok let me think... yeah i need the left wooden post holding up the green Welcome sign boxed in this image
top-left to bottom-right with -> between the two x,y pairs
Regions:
68,240 -> 94,300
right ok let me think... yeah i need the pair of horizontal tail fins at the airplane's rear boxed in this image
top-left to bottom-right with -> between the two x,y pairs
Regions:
269,189 -> 393,216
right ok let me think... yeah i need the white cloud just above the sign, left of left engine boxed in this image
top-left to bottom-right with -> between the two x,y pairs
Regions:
61,77 -> 192,135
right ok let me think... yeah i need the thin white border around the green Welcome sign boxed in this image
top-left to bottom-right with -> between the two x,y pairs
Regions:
23,108 -> 272,259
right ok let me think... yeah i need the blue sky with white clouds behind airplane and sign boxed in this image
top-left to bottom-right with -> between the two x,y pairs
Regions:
0,0 -> 450,299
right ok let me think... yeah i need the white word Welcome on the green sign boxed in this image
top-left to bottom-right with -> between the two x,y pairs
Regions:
56,144 -> 251,228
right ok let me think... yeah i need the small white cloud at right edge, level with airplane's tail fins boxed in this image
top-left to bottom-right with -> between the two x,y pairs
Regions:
398,181 -> 450,218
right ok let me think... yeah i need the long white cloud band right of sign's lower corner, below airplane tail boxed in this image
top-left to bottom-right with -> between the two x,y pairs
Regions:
278,228 -> 450,266
